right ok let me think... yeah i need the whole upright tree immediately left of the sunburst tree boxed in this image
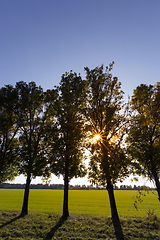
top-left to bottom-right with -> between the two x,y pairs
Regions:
50,72 -> 86,218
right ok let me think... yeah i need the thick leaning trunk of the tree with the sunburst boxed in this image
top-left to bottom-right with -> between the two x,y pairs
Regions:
107,183 -> 124,240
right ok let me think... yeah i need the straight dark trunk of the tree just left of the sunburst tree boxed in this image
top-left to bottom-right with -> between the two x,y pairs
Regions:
63,173 -> 69,218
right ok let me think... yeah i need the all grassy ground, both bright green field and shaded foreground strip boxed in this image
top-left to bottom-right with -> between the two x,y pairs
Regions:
0,189 -> 160,240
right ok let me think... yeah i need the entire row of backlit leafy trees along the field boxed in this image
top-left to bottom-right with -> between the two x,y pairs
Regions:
0,63 -> 160,239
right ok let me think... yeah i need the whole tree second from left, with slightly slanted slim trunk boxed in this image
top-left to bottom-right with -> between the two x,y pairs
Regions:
16,81 -> 54,216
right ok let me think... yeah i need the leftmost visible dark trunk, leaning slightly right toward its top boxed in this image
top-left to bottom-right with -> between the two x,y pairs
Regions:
21,174 -> 31,217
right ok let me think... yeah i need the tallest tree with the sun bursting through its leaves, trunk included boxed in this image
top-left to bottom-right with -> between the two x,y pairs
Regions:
84,63 -> 129,239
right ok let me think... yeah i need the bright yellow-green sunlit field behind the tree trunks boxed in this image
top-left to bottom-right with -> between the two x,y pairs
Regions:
0,189 -> 160,218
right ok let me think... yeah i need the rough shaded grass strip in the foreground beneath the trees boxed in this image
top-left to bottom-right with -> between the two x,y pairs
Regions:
0,211 -> 160,240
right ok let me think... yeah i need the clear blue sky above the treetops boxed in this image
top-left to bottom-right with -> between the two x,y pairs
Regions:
0,0 -> 160,188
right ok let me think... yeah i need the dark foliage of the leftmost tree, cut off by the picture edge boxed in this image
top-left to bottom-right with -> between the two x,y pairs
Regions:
0,85 -> 19,183
